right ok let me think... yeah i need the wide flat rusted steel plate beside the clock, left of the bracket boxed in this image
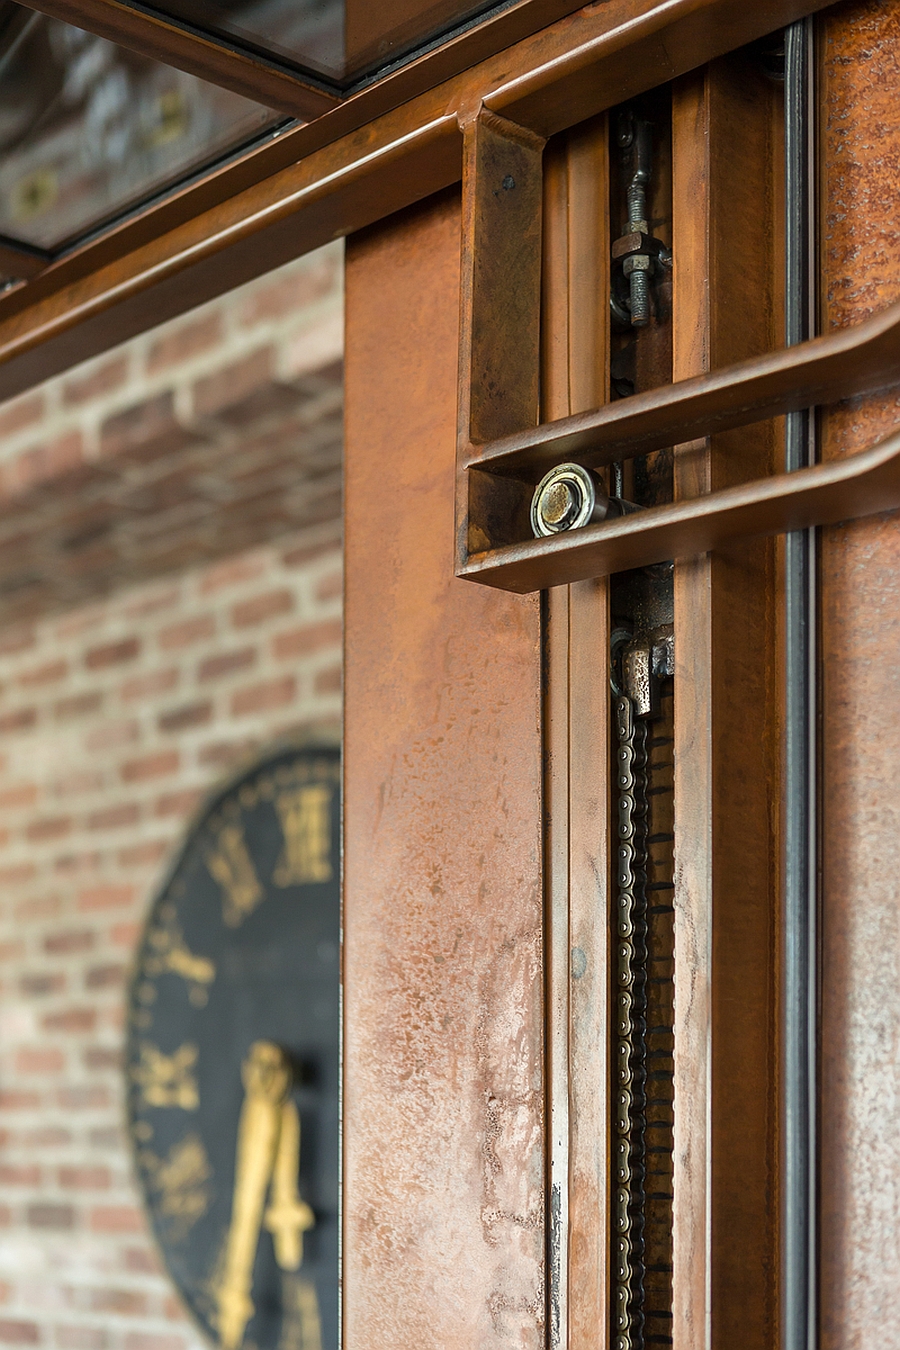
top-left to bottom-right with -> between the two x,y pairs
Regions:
344,196 -> 544,1350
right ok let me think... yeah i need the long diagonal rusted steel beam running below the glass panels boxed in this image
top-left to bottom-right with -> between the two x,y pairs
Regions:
0,0 -> 836,398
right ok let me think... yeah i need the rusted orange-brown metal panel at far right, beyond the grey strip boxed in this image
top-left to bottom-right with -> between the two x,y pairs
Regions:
820,3 -> 900,1350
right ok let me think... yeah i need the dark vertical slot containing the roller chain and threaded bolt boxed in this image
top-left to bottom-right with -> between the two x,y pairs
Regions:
610,85 -> 675,1350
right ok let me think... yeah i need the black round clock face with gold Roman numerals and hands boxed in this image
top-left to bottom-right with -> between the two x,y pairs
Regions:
125,749 -> 340,1350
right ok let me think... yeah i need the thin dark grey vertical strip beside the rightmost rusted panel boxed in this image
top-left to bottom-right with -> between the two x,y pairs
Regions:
781,19 -> 816,1350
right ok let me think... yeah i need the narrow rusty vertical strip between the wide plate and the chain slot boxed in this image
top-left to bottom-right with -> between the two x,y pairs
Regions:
541,119 -> 611,1350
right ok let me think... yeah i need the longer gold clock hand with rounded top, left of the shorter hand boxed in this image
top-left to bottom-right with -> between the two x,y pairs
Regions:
216,1041 -> 291,1350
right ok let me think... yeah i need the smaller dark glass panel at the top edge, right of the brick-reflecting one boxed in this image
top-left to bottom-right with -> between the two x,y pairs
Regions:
141,0 -> 495,85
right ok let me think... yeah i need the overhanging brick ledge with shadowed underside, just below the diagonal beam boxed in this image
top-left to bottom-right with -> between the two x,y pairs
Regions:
0,238 -> 341,622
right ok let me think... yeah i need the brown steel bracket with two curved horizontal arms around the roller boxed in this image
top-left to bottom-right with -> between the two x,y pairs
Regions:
456,105 -> 900,594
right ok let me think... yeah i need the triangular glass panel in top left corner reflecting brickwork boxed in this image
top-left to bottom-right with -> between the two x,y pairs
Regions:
0,3 -> 283,250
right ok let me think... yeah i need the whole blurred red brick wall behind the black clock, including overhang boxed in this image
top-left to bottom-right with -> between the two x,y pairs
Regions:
0,250 -> 341,1350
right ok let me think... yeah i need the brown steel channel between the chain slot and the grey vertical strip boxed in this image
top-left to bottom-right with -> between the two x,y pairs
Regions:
672,55 -> 781,1350
